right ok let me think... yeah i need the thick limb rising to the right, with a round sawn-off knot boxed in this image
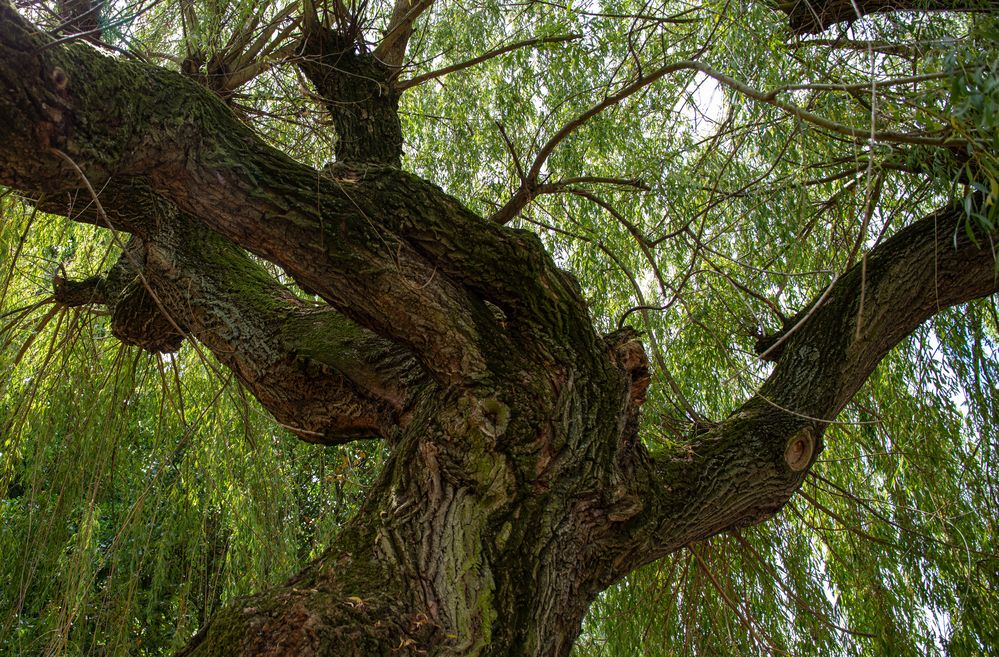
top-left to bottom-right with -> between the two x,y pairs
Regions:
592,207 -> 999,580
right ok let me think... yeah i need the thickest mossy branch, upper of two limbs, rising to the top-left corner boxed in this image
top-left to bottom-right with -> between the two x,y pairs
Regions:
0,4 -> 596,383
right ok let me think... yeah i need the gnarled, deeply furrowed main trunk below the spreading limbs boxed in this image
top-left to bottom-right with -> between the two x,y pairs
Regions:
176,332 -> 646,657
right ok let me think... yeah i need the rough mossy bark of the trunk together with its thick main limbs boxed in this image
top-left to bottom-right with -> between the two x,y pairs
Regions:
0,4 -> 996,657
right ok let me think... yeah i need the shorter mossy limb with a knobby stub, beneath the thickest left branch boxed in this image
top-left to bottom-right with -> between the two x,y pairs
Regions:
42,185 -> 425,444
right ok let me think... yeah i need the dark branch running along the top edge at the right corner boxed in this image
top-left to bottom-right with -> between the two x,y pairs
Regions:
777,0 -> 999,36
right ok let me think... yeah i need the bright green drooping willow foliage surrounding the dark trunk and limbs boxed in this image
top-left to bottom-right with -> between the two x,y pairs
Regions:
0,0 -> 999,657
